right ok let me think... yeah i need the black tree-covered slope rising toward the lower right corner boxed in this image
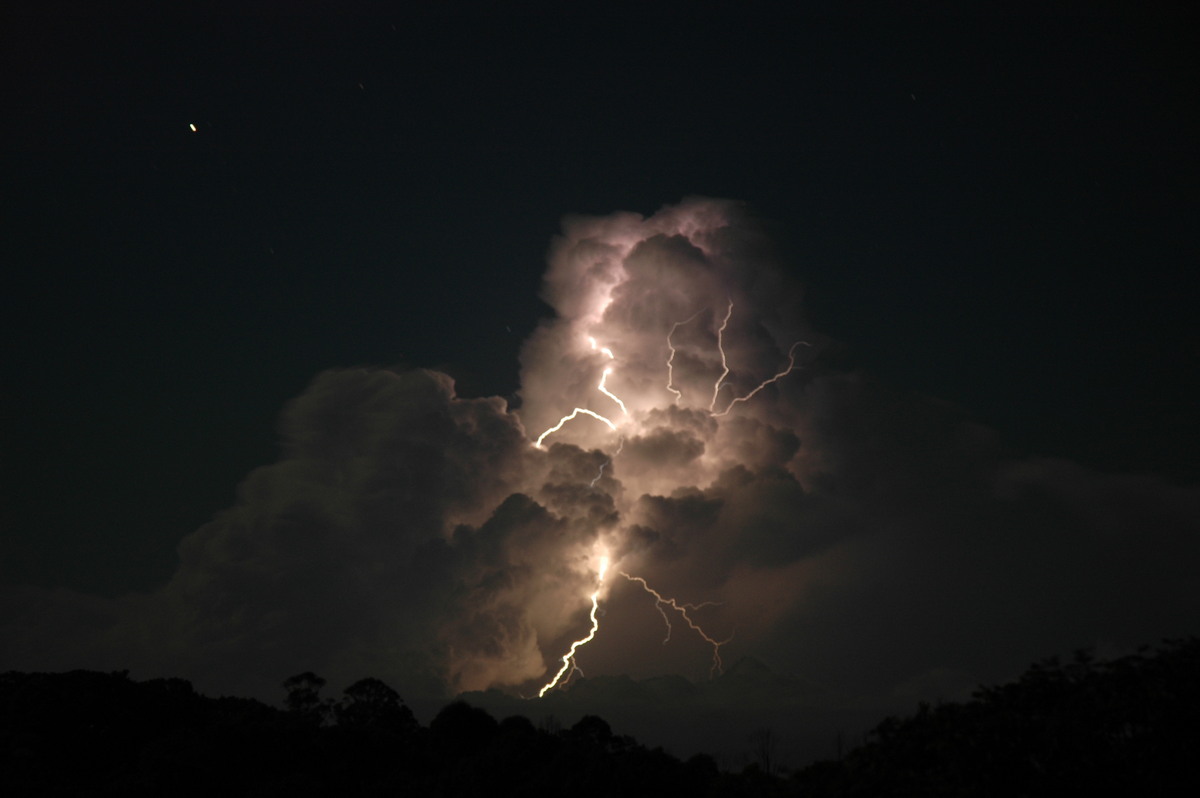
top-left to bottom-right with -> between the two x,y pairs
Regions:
793,638 -> 1200,796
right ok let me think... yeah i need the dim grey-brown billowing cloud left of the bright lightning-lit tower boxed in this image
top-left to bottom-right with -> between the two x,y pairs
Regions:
6,370 -> 565,691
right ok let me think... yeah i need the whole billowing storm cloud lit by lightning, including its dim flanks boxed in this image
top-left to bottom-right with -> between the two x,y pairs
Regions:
0,199 -> 1200,758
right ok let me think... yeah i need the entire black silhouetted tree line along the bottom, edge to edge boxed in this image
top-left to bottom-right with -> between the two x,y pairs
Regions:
0,638 -> 1200,798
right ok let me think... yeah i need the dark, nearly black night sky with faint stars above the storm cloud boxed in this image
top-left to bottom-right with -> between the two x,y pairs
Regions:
0,4 -> 1200,768
